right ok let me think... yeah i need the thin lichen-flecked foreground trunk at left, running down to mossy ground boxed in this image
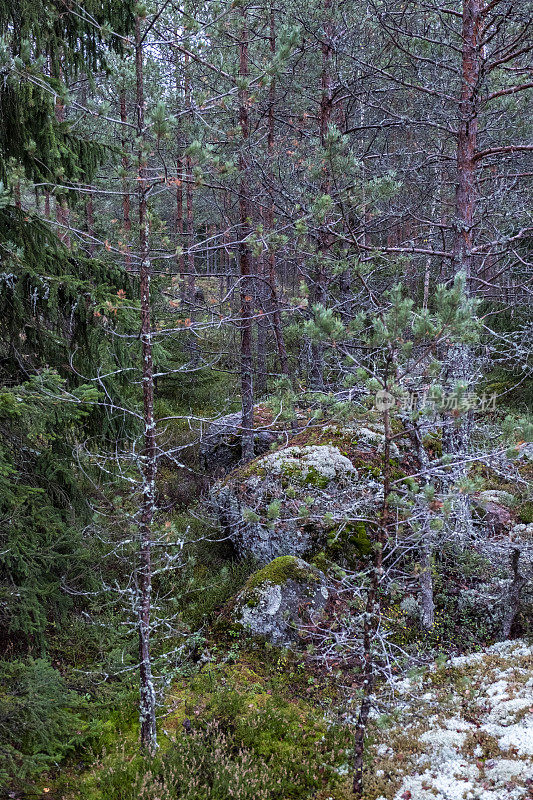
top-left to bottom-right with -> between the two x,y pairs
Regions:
135,17 -> 157,753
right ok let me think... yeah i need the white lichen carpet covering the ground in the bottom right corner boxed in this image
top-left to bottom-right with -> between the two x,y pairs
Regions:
369,641 -> 533,800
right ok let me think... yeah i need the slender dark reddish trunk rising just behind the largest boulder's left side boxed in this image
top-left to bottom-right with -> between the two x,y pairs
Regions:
239,8 -> 254,461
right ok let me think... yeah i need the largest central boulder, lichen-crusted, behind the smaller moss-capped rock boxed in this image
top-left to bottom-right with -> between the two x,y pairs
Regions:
210,445 -> 383,564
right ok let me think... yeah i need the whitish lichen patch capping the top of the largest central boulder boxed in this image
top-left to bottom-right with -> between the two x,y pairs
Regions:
263,445 -> 357,483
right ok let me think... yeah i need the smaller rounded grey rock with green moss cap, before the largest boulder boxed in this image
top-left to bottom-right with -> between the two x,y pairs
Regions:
233,556 -> 329,646
